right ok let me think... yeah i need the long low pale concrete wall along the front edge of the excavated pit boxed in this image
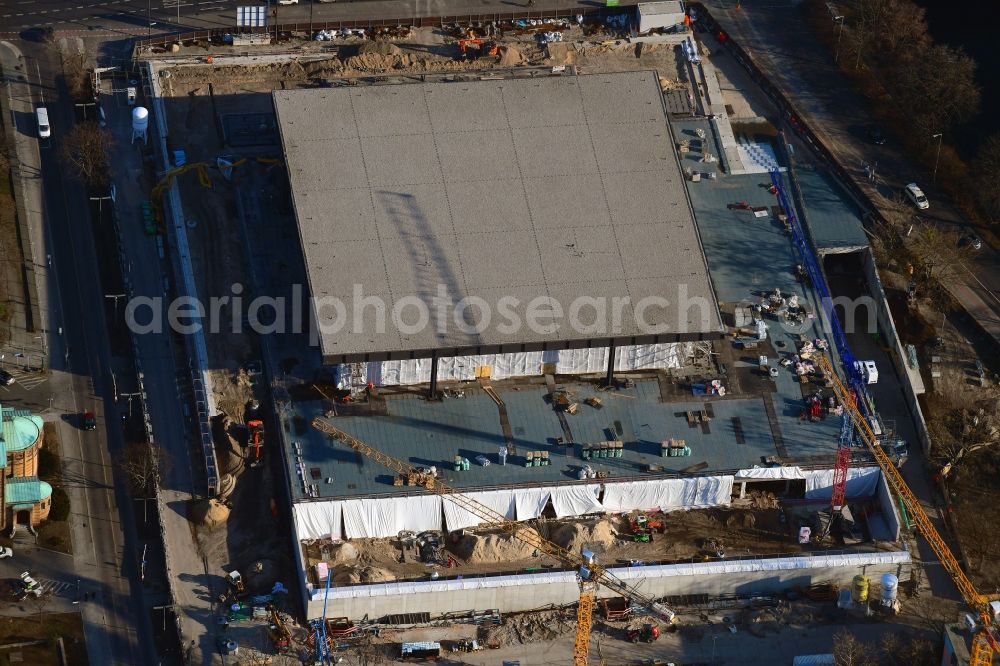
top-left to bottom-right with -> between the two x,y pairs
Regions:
306,551 -> 911,620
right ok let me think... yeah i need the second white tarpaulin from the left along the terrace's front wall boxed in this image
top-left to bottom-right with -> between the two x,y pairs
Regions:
340,495 -> 441,539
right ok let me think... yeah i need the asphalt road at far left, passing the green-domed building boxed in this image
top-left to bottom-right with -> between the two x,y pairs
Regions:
0,37 -> 152,664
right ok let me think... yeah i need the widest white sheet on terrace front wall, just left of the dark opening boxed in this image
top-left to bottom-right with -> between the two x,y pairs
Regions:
603,476 -> 733,511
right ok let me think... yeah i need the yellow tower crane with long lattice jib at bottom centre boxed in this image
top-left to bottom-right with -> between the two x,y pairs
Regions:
312,417 -> 676,666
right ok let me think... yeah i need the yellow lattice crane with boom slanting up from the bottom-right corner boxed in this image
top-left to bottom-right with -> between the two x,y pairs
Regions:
815,355 -> 1000,666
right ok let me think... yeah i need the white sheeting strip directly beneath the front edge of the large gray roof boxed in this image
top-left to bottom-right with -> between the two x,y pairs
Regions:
339,342 -> 691,386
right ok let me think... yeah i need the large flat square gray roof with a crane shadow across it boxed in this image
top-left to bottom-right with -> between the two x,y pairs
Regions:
274,72 -> 722,362
